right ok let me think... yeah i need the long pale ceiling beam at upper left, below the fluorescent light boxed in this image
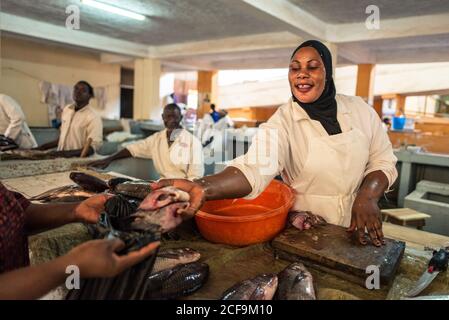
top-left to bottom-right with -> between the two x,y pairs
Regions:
0,12 -> 149,57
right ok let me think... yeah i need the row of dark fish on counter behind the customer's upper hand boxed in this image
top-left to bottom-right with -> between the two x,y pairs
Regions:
30,172 -> 152,203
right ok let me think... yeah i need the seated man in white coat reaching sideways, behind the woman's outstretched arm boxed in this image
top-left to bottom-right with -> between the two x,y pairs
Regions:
90,103 -> 204,180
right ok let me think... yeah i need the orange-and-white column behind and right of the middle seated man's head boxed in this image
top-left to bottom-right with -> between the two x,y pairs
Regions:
197,71 -> 218,119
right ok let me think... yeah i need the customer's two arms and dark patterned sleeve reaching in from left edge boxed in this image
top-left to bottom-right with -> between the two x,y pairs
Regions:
0,183 -> 159,300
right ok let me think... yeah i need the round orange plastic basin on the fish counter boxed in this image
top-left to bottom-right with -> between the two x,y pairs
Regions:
195,180 -> 294,246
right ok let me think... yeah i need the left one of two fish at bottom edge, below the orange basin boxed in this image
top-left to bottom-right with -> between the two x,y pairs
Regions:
222,274 -> 278,300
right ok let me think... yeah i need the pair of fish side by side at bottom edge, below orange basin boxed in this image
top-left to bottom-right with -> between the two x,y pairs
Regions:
222,262 -> 316,300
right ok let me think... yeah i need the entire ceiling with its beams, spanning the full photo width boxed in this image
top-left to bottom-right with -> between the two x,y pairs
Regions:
0,0 -> 449,70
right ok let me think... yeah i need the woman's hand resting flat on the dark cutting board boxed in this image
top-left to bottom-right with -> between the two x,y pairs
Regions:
348,193 -> 385,247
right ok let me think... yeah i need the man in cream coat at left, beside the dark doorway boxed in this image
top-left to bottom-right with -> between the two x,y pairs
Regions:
38,81 -> 103,157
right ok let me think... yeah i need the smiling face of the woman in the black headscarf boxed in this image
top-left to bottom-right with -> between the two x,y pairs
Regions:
288,47 -> 326,103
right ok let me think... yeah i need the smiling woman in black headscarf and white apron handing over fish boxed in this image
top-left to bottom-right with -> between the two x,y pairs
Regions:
153,40 -> 397,246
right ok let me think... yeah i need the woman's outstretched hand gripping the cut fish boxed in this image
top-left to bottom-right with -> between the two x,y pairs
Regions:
151,179 -> 206,219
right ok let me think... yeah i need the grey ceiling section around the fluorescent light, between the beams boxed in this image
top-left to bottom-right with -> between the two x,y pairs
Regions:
1,0 -> 282,46
